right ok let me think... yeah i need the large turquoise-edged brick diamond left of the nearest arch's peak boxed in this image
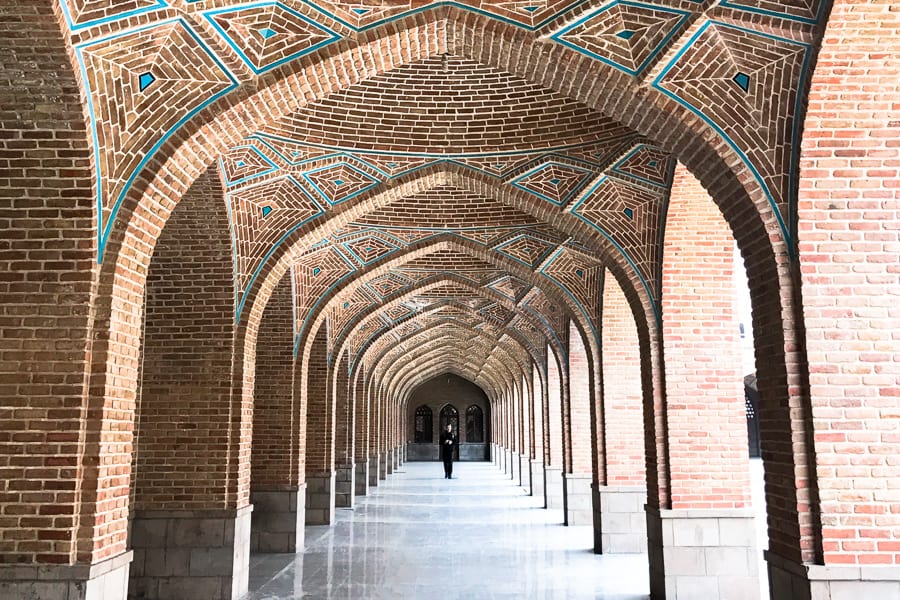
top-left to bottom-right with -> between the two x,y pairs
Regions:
203,2 -> 340,75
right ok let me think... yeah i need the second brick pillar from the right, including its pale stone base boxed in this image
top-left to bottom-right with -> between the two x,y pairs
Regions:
647,166 -> 759,600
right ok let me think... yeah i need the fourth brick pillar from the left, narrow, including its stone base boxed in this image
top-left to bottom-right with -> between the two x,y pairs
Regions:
300,323 -> 335,525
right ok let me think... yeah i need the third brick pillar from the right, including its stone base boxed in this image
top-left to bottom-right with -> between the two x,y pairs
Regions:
594,273 -> 647,554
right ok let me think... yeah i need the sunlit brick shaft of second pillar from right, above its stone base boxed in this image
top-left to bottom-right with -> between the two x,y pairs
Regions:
662,165 -> 749,508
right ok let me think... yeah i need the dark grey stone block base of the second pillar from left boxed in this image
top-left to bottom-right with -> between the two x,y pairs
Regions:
128,506 -> 253,600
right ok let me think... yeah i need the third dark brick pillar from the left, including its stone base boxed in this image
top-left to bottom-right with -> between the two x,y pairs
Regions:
250,273 -> 306,553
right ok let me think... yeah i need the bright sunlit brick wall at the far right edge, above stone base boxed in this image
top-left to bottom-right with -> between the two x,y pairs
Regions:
798,0 -> 900,565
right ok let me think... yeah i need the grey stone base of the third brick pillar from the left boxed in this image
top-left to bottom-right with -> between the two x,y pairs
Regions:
250,483 -> 306,554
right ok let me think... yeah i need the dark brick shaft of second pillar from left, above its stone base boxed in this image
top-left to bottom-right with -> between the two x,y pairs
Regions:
134,169 -> 241,510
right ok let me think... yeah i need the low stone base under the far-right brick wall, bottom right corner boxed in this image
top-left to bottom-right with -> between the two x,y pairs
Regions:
765,552 -> 900,600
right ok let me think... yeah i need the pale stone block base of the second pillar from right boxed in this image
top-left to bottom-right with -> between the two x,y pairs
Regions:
647,507 -> 760,600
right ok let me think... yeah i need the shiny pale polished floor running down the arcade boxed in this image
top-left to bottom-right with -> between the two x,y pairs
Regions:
246,462 -> 649,600
